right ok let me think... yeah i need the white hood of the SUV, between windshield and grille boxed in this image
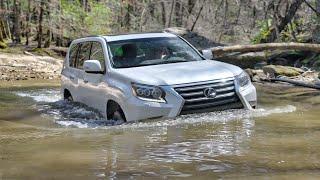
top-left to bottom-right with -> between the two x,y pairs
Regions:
112,60 -> 242,85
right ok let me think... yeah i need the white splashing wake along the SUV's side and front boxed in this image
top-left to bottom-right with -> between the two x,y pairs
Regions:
16,89 -> 296,129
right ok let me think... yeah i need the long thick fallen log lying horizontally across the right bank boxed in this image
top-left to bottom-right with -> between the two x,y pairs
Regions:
211,43 -> 320,58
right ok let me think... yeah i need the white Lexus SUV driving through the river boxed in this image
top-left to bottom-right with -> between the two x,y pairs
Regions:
61,32 -> 257,121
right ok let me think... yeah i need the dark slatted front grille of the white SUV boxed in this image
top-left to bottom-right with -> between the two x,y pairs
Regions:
174,79 -> 243,114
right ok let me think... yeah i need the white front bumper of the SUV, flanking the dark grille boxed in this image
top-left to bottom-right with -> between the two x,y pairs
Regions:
122,81 -> 257,121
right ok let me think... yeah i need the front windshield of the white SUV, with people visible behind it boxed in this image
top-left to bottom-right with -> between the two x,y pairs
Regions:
108,37 -> 203,68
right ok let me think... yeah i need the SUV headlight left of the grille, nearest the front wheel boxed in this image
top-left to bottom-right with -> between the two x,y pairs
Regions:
132,83 -> 166,103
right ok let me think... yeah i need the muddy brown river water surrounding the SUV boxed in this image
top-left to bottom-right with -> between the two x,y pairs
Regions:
0,83 -> 320,179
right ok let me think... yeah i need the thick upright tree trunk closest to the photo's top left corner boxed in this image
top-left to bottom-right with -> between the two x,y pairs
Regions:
13,0 -> 21,44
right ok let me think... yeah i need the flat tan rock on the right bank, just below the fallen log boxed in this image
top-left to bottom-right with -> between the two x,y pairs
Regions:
263,65 -> 304,78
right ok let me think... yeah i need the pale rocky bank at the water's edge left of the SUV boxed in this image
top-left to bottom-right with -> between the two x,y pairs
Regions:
0,53 -> 63,81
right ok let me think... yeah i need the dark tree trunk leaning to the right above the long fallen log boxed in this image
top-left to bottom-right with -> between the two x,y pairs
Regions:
266,0 -> 303,42
